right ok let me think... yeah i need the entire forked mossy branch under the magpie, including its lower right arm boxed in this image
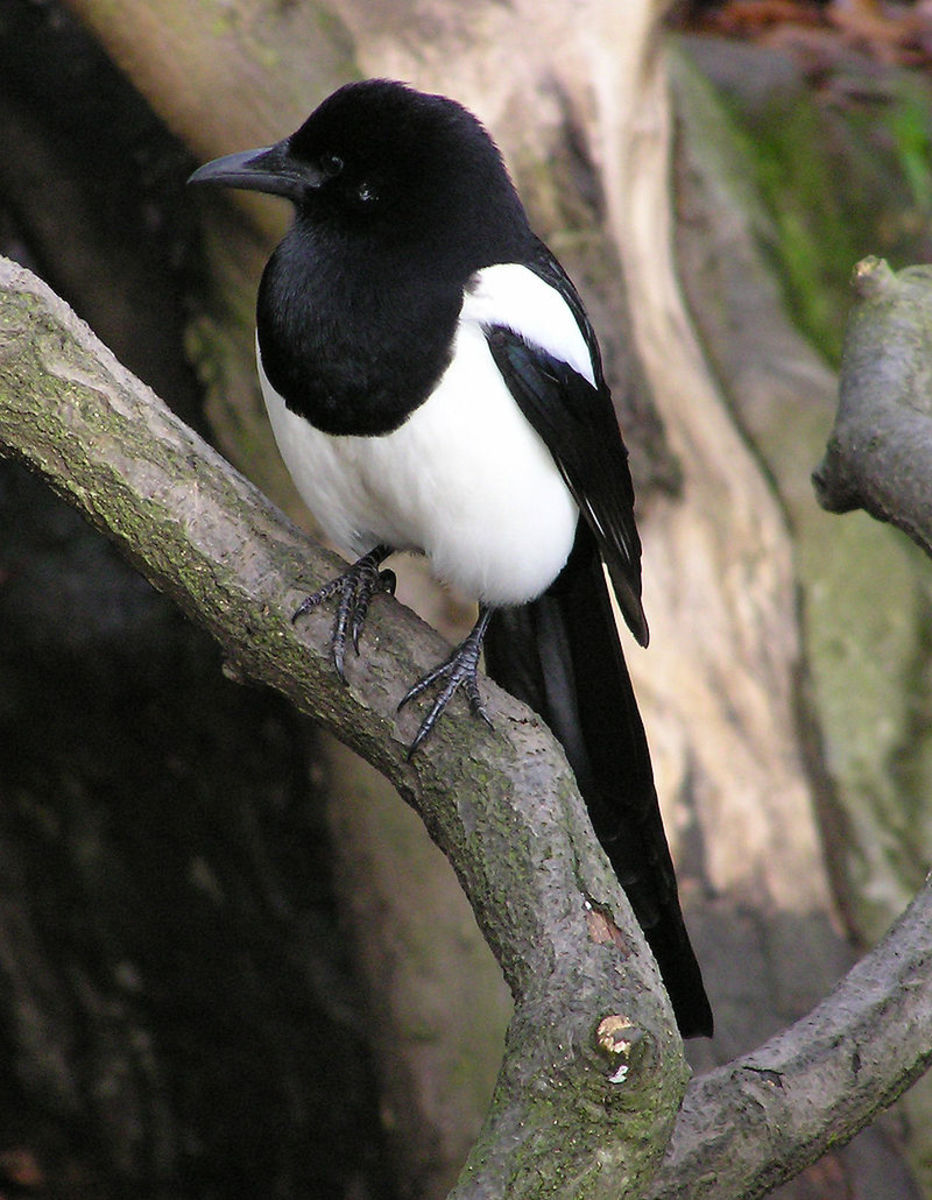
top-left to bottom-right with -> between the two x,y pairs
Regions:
0,260 -> 932,1200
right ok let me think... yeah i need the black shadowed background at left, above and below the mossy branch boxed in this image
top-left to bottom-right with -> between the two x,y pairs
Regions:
0,0 -> 393,1200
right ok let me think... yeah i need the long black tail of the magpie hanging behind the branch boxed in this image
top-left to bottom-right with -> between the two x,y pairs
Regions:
485,521 -> 712,1038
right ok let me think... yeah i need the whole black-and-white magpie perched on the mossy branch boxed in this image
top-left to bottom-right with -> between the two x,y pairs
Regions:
190,79 -> 712,1037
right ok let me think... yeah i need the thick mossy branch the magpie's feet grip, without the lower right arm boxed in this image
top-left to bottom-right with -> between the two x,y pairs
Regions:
0,260 -> 685,1200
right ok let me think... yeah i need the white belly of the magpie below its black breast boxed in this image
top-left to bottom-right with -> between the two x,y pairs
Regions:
257,322 -> 578,605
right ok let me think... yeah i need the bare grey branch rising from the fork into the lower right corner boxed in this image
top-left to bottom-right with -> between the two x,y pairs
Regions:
649,878 -> 932,1200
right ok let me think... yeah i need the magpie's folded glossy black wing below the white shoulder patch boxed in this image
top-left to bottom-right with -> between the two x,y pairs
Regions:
486,325 -> 648,646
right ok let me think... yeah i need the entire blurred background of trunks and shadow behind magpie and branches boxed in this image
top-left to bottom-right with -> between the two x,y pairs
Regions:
0,0 -> 932,1200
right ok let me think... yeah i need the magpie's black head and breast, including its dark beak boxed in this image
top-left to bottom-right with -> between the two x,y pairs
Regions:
191,79 -> 534,436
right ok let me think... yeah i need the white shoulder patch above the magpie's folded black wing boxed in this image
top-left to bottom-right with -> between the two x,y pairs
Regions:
459,263 -> 595,384
